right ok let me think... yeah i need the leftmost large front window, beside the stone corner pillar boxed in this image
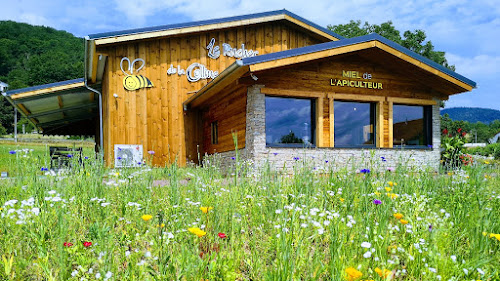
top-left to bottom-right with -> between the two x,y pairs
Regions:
266,96 -> 315,147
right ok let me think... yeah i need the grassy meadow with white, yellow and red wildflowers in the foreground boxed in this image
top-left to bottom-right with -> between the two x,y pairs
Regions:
0,143 -> 500,281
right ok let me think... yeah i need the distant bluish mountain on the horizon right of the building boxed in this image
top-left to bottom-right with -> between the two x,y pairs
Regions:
441,107 -> 500,124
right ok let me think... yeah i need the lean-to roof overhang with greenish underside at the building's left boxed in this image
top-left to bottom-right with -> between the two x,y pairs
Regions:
4,78 -> 98,135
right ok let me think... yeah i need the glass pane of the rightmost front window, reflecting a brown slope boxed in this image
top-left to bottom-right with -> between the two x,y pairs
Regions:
392,104 -> 426,146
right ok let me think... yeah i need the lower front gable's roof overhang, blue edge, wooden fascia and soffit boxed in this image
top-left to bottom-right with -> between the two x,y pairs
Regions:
184,34 -> 476,107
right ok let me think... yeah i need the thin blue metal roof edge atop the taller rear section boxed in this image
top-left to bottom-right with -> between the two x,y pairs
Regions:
88,9 -> 344,39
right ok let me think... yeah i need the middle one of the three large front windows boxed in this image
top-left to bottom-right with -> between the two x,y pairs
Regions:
334,101 -> 375,147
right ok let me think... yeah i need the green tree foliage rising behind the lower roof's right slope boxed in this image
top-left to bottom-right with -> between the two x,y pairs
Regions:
328,20 -> 455,70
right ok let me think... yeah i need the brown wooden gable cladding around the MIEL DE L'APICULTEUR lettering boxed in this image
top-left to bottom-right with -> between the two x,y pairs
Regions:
255,51 -> 448,99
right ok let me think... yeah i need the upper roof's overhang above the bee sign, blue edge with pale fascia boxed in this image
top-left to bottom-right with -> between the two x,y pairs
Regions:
88,10 -> 343,46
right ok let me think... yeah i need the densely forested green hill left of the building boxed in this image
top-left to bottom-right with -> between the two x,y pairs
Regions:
0,21 -> 84,90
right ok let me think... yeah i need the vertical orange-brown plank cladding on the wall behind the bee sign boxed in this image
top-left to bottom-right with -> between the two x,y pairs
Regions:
97,22 -> 326,165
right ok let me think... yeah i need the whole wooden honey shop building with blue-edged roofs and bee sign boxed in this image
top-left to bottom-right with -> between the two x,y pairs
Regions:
3,10 -> 475,170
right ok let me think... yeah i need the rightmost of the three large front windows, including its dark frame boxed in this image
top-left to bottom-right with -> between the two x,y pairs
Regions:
392,104 -> 432,147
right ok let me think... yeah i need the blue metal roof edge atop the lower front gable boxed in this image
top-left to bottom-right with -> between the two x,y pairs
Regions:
242,33 -> 476,88
